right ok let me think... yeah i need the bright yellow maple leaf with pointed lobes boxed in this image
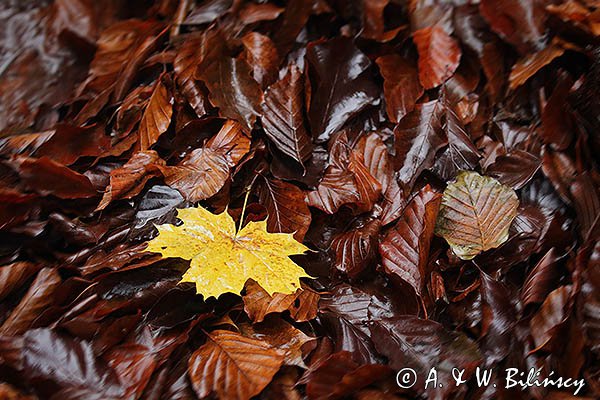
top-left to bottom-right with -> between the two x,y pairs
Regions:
147,207 -> 310,299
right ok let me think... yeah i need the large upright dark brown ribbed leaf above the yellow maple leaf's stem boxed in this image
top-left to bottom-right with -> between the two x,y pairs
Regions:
261,65 -> 312,165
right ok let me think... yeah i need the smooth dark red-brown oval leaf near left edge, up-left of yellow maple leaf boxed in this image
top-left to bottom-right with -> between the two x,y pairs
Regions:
16,157 -> 98,199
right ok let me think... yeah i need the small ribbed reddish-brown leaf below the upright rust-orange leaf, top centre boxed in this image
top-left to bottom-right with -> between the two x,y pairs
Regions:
354,132 -> 394,192
